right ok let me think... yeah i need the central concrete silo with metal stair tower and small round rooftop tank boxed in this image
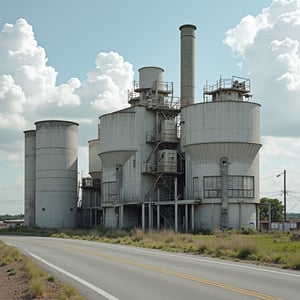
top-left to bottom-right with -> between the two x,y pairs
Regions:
100,66 -> 179,228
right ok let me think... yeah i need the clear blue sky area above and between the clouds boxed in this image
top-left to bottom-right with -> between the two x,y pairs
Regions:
0,0 -> 271,98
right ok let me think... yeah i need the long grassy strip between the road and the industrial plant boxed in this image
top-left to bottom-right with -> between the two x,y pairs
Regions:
0,227 -> 300,270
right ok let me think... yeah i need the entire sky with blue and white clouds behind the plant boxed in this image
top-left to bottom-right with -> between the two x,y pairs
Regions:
0,0 -> 300,215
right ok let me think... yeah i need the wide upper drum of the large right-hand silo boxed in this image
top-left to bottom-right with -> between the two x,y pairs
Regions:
181,101 -> 260,155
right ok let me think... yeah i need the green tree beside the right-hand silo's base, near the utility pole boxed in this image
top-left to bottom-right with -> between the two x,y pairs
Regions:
260,198 -> 284,222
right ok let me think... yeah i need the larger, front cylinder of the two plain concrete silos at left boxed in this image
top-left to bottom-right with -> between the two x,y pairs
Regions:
35,120 -> 78,228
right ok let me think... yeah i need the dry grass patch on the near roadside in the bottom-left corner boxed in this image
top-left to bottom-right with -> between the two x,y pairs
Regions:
0,241 -> 83,300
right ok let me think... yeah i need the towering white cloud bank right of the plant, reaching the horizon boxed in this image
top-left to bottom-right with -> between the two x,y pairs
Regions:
224,0 -> 300,212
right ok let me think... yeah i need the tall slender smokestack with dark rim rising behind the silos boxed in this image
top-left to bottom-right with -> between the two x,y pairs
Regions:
179,24 -> 197,107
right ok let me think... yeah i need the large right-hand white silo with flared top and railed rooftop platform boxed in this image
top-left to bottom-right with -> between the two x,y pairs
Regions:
181,77 -> 261,229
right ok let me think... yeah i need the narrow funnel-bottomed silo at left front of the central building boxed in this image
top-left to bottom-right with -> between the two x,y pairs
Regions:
99,109 -> 137,227
